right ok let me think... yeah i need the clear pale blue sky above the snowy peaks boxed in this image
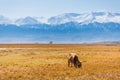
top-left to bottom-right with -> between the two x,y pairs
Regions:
0,0 -> 120,18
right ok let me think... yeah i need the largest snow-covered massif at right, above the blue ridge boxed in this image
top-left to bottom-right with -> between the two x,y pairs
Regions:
48,12 -> 120,24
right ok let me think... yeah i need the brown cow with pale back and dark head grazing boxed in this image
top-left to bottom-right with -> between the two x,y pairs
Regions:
68,53 -> 82,68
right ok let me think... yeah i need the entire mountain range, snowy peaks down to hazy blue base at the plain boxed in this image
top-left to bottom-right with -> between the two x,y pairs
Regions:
0,12 -> 120,43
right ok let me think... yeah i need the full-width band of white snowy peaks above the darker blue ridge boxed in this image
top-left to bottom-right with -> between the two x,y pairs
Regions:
0,12 -> 120,25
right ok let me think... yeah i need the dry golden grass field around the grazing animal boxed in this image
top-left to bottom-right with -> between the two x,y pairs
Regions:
0,44 -> 120,80
